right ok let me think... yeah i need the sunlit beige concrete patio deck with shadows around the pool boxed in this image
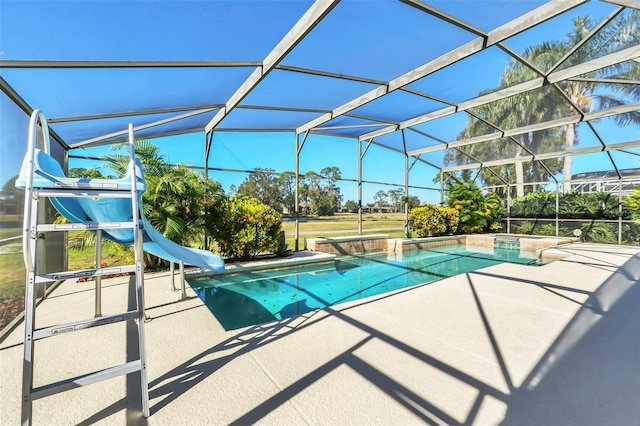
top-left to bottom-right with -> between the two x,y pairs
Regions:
0,244 -> 640,425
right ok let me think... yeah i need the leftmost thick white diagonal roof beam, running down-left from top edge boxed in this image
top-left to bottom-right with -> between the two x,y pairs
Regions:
205,0 -> 339,133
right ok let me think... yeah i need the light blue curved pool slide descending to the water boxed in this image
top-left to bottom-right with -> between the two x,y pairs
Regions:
16,113 -> 224,272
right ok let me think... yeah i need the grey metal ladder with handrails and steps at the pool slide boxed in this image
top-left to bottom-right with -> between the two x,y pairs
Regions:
16,110 -> 149,425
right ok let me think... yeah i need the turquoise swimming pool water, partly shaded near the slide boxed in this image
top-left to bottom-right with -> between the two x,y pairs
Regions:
190,245 -> 542,330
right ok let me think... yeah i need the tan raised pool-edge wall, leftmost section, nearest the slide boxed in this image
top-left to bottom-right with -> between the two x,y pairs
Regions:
304,234 -> 389,255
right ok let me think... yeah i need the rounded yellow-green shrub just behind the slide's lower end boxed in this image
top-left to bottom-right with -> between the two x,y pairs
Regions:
209,195 -> 282,260
